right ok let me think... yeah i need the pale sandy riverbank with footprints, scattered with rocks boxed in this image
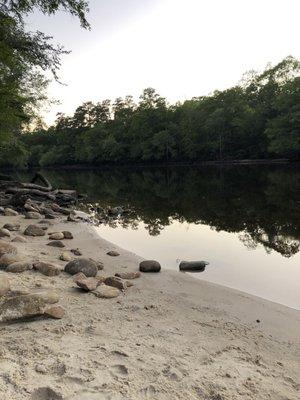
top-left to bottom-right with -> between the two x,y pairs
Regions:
0,216 -> 300,400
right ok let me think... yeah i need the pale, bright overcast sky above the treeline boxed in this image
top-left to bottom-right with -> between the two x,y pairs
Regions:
27,0 -> 300,124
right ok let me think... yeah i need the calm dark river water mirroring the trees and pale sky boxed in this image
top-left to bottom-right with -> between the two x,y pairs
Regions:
21,165 -> 300,309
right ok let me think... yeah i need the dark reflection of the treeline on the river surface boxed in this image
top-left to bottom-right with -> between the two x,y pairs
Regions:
19,165 -> 300,257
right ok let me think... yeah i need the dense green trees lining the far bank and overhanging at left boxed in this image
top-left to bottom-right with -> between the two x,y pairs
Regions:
0,0 -> 300,167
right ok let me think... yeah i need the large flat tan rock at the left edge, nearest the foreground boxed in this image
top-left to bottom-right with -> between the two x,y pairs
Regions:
0,291 -> 59,322
